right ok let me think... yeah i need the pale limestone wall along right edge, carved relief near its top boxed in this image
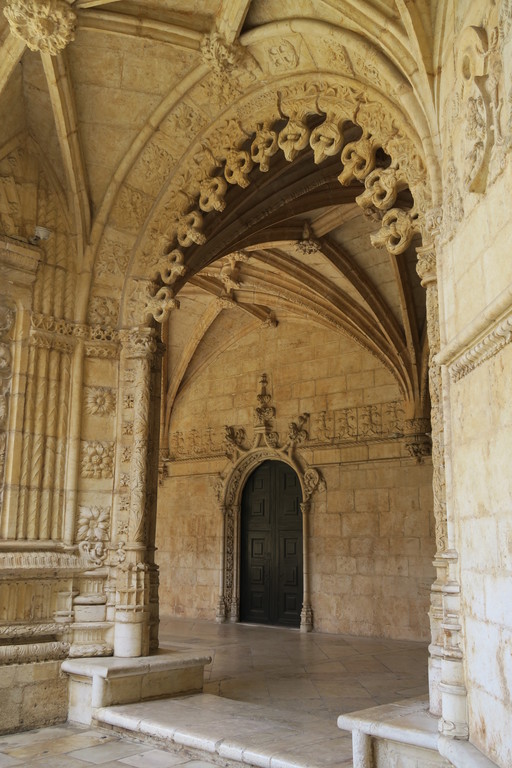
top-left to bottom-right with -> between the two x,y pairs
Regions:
437,2 -> 512,768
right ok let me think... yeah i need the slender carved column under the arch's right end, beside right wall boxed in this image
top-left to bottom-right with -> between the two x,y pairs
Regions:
417,244 -> 468,739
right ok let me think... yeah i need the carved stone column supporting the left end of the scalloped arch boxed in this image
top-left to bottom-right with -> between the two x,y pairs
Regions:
114,328 -> 158,657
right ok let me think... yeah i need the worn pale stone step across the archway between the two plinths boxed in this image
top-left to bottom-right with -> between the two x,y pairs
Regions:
95,694 -> 353,768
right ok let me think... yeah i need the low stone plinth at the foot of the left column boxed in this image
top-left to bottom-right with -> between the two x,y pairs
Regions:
62,651 -> 211,724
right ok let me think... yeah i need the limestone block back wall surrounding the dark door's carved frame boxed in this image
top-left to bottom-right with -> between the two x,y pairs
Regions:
157,317 -> 435,639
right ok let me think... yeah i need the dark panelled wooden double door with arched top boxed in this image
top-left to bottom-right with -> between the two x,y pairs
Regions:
240,461 -> 303,627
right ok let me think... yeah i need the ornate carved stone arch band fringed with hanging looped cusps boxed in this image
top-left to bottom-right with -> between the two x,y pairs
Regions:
121,67 -> 431,323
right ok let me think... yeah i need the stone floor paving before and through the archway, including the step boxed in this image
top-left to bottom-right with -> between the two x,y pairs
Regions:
0,619 -> 427,768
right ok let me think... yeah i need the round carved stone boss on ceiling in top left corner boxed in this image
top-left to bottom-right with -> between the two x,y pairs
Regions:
4,0 -> 76,56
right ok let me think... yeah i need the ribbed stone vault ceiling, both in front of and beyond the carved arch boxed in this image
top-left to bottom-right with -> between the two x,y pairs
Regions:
0,0 -> 443,432
